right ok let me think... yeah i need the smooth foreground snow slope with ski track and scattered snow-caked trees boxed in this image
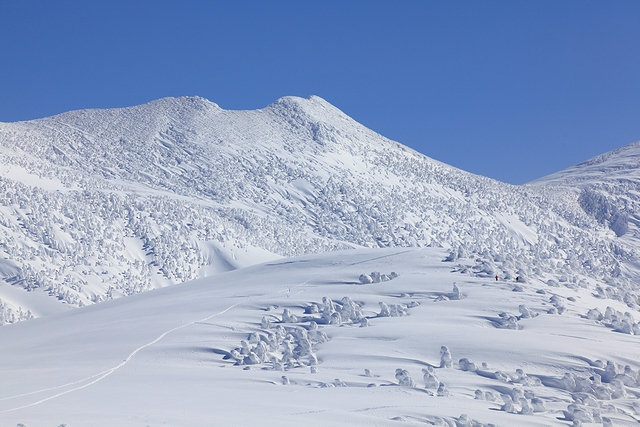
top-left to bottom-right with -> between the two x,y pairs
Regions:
0,248 -> 640,427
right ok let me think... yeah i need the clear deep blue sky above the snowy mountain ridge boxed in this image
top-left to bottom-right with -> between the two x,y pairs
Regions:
0,0 -> 640,184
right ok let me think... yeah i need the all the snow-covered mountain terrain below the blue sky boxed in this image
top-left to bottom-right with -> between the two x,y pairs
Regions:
0,96 -> 640,427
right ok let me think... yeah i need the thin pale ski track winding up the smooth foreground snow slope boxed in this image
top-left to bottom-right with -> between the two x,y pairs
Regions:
0,248 -> 422,414
